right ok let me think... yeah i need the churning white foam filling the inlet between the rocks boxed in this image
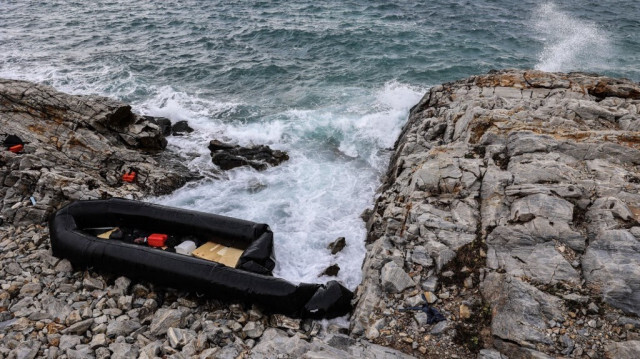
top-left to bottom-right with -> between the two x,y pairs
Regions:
149,82 -> 424,289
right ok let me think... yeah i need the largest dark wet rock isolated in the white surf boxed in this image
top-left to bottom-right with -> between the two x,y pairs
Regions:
209,140 -> 289,171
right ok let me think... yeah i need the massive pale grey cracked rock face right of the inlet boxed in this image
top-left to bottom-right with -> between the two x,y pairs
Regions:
352,70 -> 640,357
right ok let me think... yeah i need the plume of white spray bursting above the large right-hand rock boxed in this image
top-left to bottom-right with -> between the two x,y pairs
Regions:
533,2 -> 612,72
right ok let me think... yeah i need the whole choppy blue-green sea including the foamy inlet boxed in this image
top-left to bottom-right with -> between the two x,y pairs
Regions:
0,0 -> 640,289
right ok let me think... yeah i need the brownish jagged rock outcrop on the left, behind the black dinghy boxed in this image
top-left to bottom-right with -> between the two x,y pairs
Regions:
0,80 -> 192,224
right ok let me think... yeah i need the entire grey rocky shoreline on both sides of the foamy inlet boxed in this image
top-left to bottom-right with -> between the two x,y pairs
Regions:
0,70 -> 640,359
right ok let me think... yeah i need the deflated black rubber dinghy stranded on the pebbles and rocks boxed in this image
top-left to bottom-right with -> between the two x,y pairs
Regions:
49,198 -> 353,318
